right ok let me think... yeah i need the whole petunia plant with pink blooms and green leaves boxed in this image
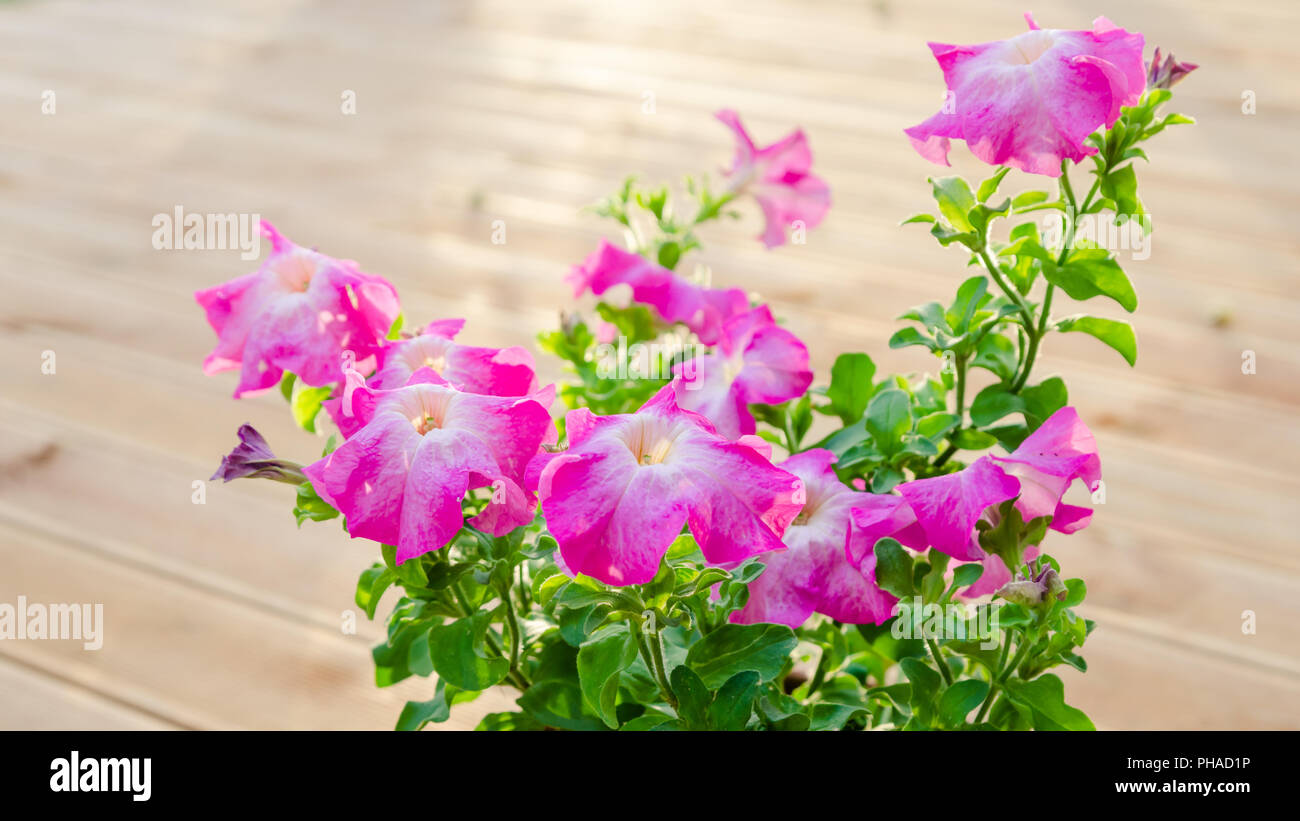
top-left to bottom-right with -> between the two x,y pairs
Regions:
196,18 -> 1195,730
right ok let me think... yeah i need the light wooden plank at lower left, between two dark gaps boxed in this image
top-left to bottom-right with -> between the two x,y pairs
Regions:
0,522 -> 510,730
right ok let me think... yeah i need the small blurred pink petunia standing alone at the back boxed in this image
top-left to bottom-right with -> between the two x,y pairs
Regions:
715,109 -> 831,248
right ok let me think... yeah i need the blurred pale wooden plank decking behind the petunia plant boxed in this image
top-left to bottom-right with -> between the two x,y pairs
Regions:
0,0 -> 1300,729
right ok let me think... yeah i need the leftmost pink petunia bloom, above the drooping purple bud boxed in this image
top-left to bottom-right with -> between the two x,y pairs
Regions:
194,221 -> 400,399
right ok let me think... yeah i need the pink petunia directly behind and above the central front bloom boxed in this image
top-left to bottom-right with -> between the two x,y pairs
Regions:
672,305 -> 813,439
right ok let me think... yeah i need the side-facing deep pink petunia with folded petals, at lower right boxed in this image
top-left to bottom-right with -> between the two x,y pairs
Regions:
849,408 -> 1101,574
